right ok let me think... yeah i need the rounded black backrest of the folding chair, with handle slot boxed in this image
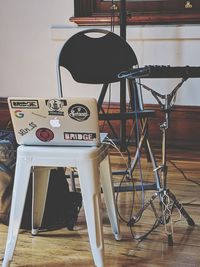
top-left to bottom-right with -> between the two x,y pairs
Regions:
58,29 -> 138,84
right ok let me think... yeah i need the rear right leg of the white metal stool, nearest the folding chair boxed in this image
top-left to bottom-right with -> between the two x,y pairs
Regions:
100,156 -> 121,240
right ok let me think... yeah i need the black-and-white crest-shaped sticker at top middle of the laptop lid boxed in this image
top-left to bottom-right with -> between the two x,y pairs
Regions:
45,99 -> 67,116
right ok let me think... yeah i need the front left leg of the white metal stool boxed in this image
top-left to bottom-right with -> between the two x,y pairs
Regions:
2,156 -> 31,267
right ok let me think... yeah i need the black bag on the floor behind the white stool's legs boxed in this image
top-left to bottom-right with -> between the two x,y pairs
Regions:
21,168 -> 82,230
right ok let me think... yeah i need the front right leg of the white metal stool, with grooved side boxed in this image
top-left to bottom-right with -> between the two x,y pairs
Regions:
77,159 -> 104,267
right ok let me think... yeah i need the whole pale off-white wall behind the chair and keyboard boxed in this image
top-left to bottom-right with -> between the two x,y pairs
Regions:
0,0 -> 200,106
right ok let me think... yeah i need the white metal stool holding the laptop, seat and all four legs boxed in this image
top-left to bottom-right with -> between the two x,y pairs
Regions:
2,144 -> 120,267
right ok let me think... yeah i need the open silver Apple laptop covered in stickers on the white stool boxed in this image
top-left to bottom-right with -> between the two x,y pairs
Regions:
8,97 -> 100,146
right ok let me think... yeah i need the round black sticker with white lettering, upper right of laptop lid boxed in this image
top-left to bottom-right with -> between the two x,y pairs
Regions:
68,104 -> 90,121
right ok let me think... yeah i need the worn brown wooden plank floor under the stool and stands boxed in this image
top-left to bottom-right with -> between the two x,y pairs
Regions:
0,149 -> 200,267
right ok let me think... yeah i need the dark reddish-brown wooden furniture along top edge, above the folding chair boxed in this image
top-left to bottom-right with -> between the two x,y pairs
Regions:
70,0 -> 200,26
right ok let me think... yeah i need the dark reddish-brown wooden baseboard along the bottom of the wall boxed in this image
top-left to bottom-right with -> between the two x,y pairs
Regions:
0,98 -> 200,149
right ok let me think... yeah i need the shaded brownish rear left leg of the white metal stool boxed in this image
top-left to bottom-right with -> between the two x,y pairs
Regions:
32,167 -> 52,235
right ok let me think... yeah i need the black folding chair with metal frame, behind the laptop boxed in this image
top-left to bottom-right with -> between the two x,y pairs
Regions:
57,29 -> 158,191
